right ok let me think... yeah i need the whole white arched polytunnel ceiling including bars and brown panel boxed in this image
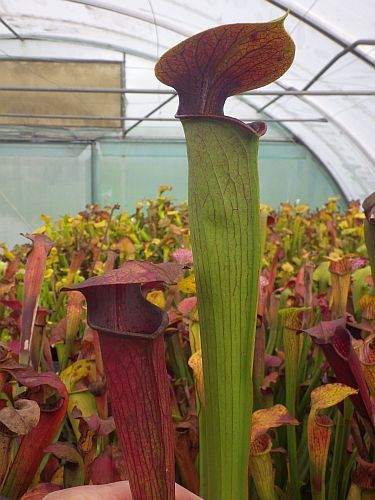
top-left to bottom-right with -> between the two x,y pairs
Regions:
0,0 -> 375,199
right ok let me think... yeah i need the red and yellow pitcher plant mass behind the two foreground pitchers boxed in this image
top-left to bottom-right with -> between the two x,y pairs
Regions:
0,190 -> 375,500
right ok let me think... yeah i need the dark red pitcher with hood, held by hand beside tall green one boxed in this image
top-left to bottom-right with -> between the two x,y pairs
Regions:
62,261 -> 183,500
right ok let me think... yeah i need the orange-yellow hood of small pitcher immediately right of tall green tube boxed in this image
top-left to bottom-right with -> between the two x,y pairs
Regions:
251,404 -> 299,442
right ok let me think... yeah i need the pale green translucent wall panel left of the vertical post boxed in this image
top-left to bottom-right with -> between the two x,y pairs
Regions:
0,144 -> 91,245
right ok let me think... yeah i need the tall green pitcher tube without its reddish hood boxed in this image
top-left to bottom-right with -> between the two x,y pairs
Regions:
182,118 -> 260,499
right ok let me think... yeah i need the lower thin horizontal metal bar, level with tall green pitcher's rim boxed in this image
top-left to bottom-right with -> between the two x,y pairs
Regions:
0,113 -> 327,123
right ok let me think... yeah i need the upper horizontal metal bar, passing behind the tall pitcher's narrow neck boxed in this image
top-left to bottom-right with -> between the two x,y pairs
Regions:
0,86 -> 375,97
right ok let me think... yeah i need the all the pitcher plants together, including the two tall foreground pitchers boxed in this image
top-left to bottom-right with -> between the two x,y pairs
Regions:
0,18 -> 375,500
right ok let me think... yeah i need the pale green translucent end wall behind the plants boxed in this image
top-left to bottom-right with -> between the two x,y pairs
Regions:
0,141 -> 345,244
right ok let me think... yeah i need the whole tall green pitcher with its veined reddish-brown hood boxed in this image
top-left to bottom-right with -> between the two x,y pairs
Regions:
155,18 -> 294,500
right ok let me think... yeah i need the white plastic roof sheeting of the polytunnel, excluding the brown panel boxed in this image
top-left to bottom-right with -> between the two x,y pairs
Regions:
0,0 -> 375,198
